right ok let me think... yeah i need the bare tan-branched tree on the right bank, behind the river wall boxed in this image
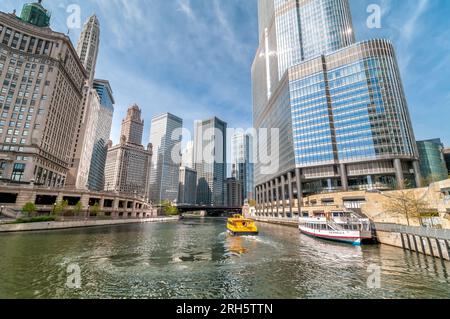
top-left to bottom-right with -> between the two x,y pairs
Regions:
384,190 -> 430,226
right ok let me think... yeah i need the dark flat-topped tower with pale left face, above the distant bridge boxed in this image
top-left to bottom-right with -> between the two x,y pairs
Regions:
194,117 -> 227,206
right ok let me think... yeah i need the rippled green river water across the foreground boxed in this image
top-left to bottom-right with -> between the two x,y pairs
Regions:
0,219 -> 450,298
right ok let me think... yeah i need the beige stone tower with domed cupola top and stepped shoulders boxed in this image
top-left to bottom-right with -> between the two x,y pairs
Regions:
105,104 -> 152,200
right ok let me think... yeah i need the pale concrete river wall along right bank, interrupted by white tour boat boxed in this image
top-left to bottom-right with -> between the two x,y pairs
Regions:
251,216 -> 450,261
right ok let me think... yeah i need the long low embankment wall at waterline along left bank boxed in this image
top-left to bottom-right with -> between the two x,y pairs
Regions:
0,216 -> 179,233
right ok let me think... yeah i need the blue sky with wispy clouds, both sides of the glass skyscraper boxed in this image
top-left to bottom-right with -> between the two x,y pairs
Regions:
0,0 -> 450,146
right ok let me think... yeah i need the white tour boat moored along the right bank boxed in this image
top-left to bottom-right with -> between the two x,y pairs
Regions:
299,211 -> 373,245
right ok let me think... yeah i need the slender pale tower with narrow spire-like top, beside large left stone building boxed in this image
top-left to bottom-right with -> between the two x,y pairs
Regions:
67,15 -> 103,189
